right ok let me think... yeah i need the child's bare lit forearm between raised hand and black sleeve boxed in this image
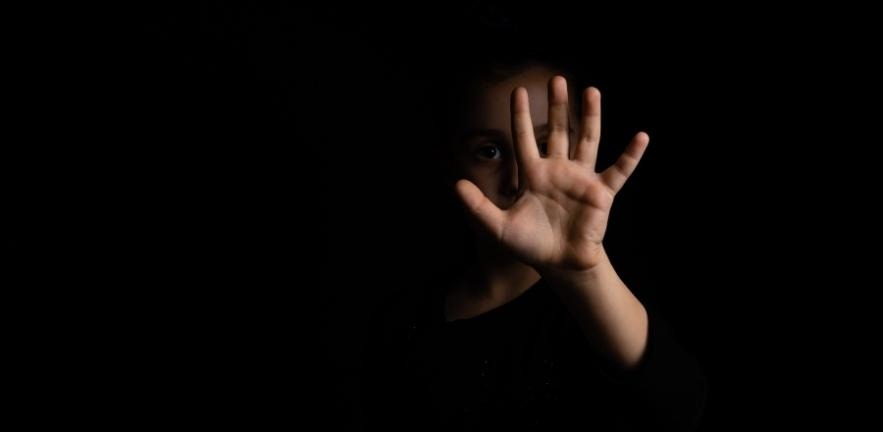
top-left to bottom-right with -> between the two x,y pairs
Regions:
543,250 -> 648,369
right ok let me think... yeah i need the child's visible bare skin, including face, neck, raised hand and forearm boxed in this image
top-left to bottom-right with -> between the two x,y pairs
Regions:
445,68 -> 649,369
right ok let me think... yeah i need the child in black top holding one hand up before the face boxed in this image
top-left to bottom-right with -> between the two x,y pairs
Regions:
362,56 -> 705,430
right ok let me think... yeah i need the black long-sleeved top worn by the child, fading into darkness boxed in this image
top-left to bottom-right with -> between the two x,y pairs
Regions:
362,281 -> 705,431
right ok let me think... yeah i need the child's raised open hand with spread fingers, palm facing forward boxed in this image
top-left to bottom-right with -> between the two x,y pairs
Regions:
457,76 -> 649,270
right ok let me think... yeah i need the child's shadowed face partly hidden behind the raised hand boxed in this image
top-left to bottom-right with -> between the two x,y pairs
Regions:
454,67 -> 576,209
